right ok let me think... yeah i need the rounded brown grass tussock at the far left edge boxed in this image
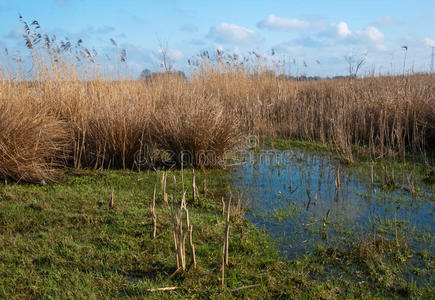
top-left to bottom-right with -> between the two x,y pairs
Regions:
0,90 -> 70,182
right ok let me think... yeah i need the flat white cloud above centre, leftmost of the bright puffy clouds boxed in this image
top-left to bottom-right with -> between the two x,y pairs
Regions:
207,23 -> 263,44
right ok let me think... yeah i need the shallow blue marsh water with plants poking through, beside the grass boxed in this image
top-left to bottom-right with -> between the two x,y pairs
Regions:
232,150 -> 435,258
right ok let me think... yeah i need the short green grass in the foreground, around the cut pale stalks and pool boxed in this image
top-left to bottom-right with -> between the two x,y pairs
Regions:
0,170 -> 434,299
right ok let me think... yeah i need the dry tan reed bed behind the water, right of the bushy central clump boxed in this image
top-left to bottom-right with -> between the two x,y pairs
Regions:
198,65 -> 435,160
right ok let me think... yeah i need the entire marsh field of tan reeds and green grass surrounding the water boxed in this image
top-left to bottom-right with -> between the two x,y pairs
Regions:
0,25 -> 435,299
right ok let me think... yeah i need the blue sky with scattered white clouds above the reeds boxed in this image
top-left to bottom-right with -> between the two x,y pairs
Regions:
0,0 -> 435,76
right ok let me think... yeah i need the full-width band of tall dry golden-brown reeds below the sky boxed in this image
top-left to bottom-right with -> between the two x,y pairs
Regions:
0,21 -> 435,181
